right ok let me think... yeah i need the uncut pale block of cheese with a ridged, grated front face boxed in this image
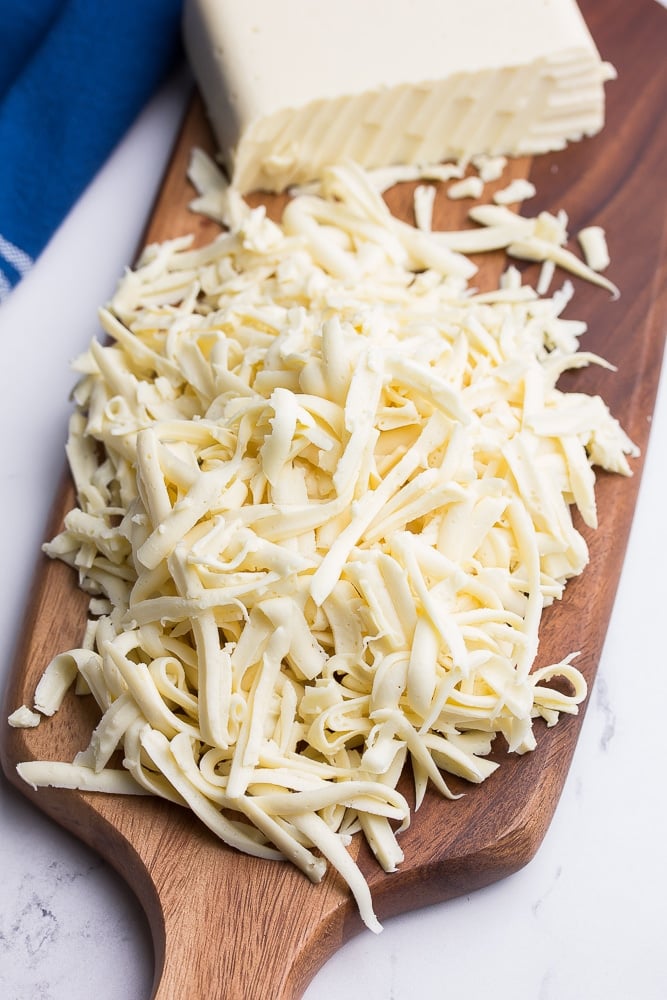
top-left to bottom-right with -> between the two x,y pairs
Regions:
183,0 -> 614,192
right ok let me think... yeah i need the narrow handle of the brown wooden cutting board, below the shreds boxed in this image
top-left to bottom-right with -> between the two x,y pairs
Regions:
135,810 -> 363,1000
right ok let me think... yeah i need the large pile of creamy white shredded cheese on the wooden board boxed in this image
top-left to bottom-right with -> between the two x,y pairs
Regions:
14,161 -> 636,930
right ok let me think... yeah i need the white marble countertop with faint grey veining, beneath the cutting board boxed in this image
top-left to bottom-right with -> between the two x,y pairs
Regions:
0,52 -> 667,1000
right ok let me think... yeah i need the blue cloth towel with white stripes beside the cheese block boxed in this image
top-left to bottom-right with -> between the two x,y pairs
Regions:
0,0 -> 181,301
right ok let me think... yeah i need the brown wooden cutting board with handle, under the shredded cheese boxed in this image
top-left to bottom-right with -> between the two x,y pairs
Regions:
0,0 -> 667,1000
